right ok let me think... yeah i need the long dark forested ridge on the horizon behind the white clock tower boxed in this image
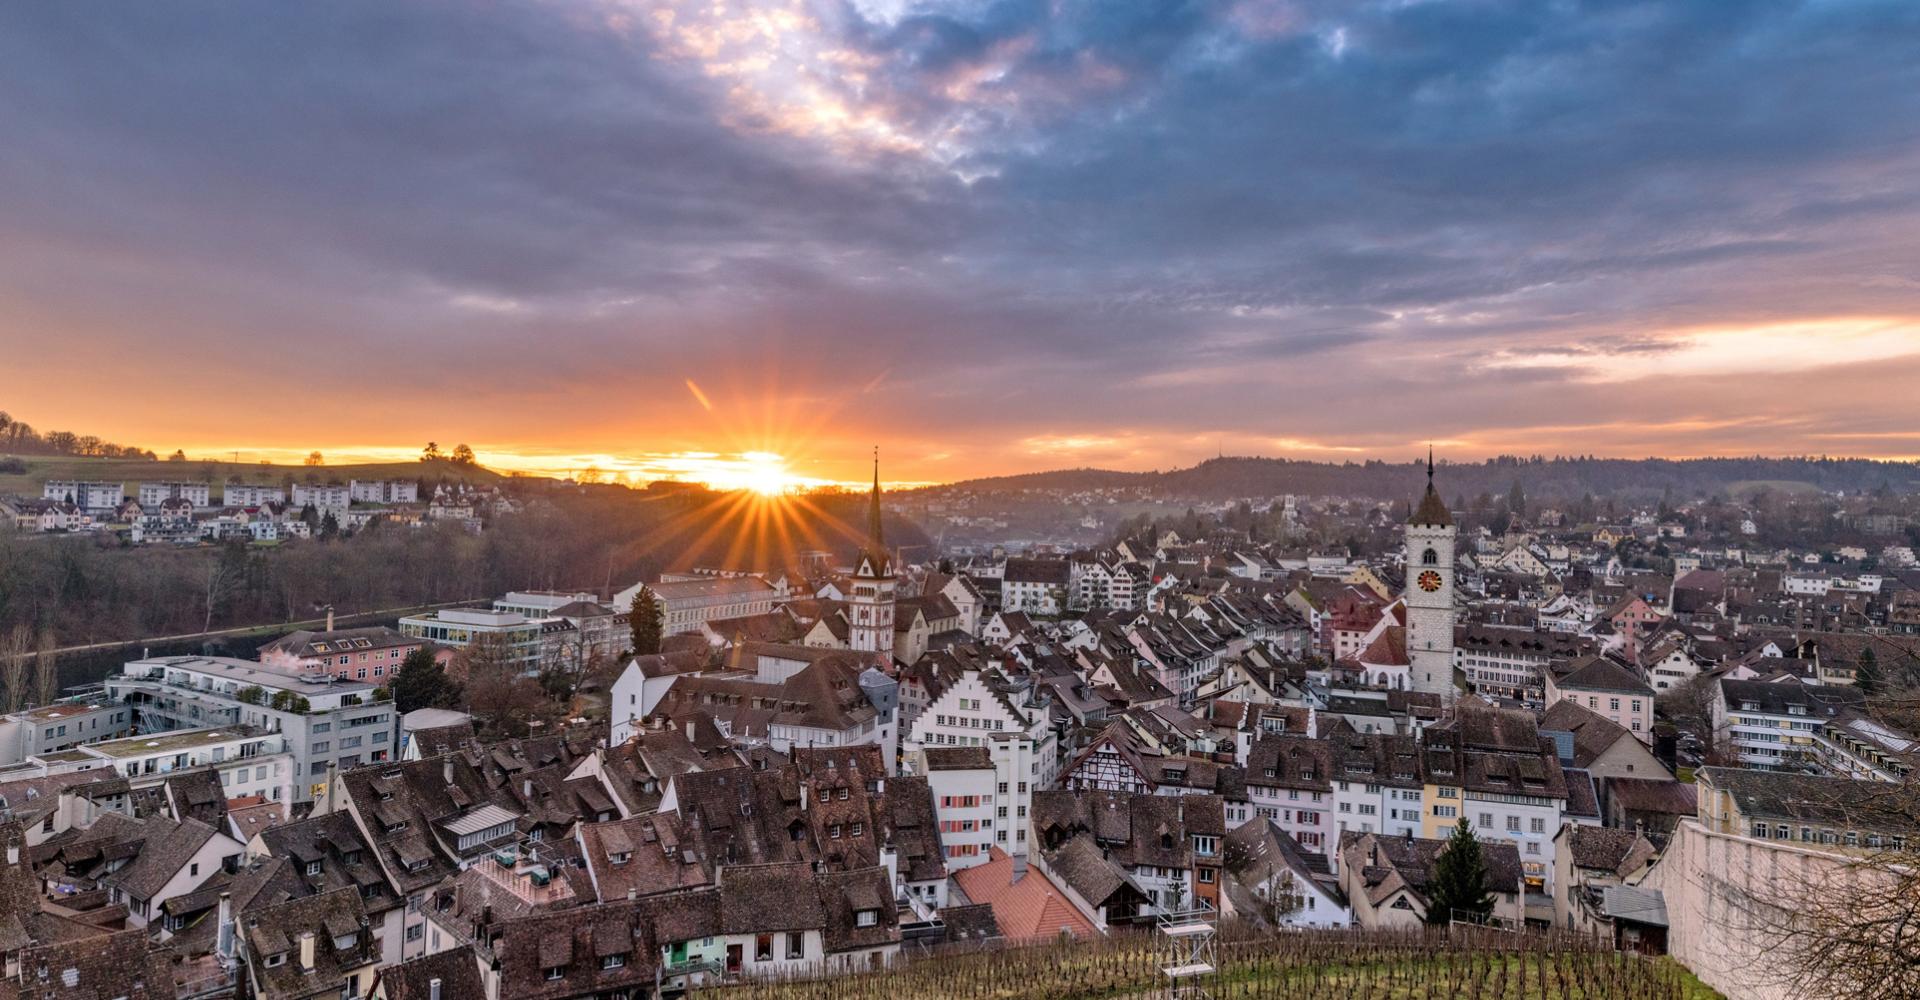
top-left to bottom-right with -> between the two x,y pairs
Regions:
935,457 -> 1920,499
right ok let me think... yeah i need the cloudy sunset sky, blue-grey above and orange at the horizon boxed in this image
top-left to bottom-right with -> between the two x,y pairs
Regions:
0,0 -> 1920,482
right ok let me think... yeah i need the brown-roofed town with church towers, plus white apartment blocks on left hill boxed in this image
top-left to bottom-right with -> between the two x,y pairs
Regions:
0,464 -> 1920,1000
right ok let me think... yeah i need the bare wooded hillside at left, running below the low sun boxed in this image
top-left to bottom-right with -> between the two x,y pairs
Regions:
0,478 -> 927,645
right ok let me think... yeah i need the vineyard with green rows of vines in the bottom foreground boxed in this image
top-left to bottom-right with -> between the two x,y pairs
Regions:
693,929 -> 1718,1000
